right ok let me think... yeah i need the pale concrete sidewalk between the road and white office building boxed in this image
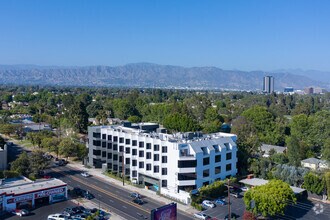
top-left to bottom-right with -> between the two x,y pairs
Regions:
67,161 -> 197,215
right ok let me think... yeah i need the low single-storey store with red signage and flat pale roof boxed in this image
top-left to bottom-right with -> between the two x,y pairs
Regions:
0,179 -> 67,211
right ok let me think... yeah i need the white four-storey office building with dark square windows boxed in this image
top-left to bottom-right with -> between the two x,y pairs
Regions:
88,123 -> 237,202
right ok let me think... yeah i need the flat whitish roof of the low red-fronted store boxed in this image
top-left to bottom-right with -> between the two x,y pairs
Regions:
0,178 -> 67,195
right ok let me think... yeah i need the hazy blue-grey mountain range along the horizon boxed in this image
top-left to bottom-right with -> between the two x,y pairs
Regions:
0,63 -> 330,91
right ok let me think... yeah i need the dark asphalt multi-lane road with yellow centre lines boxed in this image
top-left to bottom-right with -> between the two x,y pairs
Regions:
49,166 -> 192,220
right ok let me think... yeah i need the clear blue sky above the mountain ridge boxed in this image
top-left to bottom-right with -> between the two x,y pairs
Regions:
0,0 -> 330,71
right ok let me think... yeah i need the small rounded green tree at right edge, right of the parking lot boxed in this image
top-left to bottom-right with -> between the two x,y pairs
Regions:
303,172 -> 325,195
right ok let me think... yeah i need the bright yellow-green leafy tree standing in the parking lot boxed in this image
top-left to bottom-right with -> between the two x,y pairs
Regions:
244,180 -> 296,217
